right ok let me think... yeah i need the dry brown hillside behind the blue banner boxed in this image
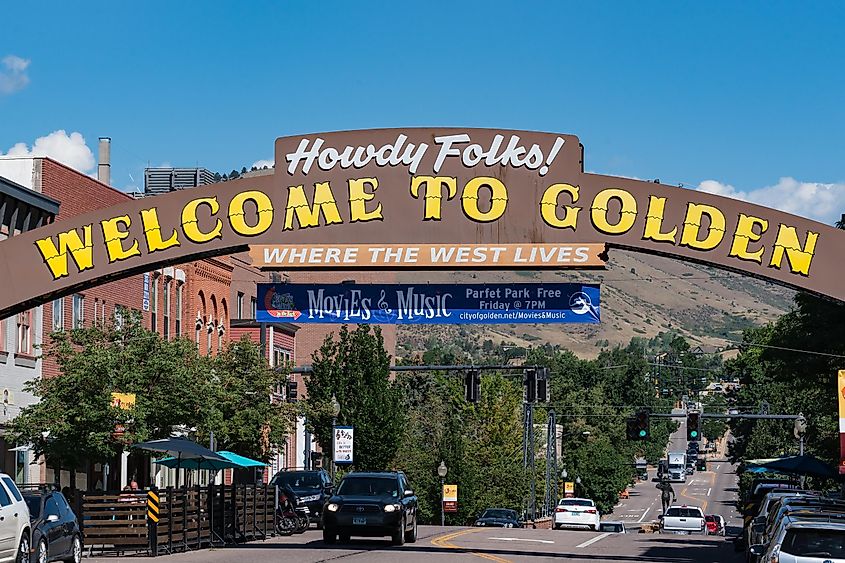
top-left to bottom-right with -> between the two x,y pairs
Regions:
396,250 -> 794,358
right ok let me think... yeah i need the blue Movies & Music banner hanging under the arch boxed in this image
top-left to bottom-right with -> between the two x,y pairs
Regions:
256,283 -> 600,324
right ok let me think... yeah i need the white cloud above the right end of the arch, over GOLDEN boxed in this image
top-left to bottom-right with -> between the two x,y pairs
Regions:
696,177 -> 845,225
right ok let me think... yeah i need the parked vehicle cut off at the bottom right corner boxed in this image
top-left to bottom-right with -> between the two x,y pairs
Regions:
749,516 -> 845,563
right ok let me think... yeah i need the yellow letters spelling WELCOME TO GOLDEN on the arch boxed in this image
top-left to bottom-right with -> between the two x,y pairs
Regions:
35,176 -> 819,279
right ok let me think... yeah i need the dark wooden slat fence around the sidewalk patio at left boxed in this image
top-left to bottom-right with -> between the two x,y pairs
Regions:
75,485 -> 276,556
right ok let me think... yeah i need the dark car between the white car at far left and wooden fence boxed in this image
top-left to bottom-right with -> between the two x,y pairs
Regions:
23,490 -> 82,563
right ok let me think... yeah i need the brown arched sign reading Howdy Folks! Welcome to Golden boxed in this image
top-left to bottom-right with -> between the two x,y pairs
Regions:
0,128 -> 845,318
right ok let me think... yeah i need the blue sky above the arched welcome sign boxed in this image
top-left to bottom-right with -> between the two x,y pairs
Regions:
0,1 -> 845,221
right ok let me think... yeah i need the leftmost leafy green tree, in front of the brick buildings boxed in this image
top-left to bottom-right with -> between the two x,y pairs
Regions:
9,316 -> 208,482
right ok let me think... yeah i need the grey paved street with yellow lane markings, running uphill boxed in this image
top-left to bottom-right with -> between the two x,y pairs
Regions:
88,412 -> 743,563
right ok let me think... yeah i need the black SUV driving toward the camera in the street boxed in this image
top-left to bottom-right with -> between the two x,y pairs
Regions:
323,471 -> 417,545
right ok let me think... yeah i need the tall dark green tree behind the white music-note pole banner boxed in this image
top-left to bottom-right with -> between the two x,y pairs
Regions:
305,325 -> 404,470
